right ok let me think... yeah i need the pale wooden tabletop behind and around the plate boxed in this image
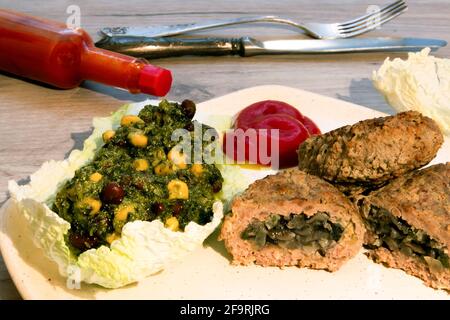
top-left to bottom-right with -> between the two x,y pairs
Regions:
0,0 -> 450,299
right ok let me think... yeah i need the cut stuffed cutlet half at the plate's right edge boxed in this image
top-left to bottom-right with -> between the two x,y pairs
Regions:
360,162 -> 450,290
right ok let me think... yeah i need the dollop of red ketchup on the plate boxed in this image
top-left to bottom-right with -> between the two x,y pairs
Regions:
223,100 -> 321,168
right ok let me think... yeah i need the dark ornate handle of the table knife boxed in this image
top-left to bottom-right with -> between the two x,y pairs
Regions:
95,36 -> 245,59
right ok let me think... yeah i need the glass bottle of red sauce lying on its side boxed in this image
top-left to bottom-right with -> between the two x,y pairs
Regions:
0,9 -> 172,96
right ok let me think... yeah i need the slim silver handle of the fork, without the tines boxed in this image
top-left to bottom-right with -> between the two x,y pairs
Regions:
100,16 -> 300,38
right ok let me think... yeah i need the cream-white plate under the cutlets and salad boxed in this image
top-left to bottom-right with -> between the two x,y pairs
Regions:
0,86 -> 450,299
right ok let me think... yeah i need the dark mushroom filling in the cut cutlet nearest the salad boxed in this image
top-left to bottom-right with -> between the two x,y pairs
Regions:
241,212 -> 344,256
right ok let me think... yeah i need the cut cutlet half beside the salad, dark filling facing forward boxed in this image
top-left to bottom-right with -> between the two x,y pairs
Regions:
220,168 -> 364,271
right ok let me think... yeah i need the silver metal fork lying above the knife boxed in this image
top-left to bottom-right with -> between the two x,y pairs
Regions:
101,0 -> 408,39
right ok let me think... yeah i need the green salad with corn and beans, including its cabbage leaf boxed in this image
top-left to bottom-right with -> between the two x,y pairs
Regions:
9,100 -> 247,288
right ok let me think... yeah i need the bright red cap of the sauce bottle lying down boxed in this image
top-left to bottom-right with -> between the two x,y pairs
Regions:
139,64 -> 172,97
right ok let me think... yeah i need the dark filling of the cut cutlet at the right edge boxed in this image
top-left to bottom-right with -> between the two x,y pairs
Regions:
365,206 -> 450,271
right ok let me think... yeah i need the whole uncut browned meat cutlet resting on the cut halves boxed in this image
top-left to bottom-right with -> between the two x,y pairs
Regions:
298,111 -> 443,195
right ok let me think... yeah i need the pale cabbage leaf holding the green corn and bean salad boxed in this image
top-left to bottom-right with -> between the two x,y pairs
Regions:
9,101 -> 247,288
